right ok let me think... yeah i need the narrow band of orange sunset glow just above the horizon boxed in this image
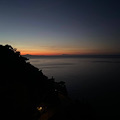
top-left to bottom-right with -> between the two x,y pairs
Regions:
18,48 -> 119,55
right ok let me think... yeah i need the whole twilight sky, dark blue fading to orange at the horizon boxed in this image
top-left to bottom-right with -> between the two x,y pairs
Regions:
0,0 -> 120,55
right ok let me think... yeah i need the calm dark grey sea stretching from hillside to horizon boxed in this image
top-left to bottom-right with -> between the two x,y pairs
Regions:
29,56 -> 120,117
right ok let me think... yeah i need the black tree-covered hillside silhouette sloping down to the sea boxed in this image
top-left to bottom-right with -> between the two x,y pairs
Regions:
0,45 -> 95,120
